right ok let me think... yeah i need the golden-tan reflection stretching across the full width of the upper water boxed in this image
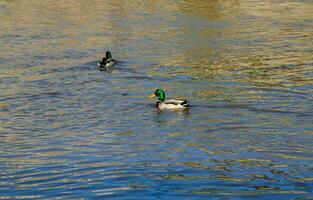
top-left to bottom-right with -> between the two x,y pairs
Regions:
0,0 -> 313,82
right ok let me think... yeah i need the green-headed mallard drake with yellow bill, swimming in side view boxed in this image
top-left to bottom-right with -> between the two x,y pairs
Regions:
149,89 -> 189,110
